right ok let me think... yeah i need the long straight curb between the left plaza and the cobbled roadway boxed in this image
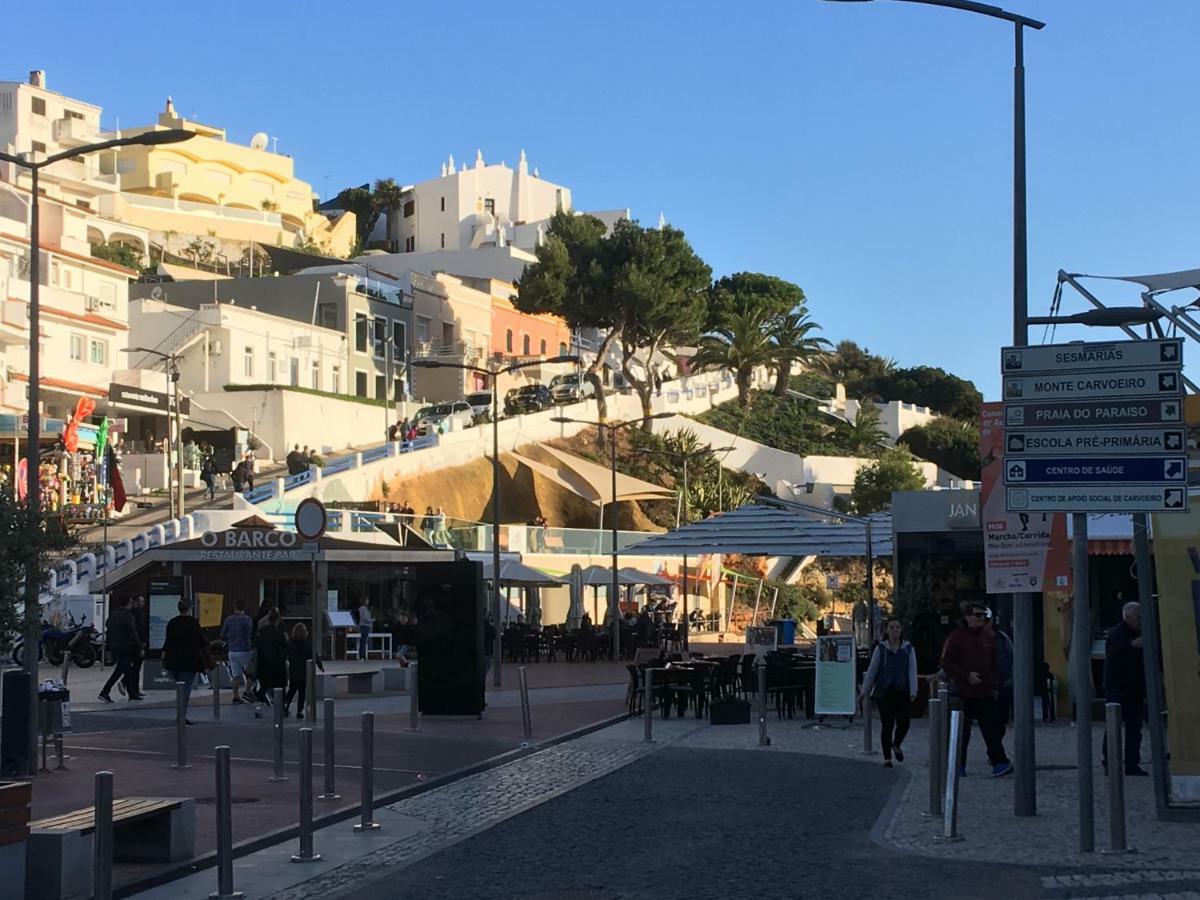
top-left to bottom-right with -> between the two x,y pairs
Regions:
113,713 -> 629,898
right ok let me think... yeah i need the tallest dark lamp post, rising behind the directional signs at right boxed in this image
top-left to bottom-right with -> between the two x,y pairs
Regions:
830,0 -> 1045,816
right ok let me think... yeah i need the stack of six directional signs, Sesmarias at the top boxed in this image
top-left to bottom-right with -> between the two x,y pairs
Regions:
1001,338 -> 1188,512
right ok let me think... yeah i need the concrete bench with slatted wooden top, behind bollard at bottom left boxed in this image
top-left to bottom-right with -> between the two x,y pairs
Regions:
25,797 -> 196,900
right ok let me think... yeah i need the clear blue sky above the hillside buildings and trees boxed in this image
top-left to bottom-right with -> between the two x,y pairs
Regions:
11,0 -> 1200,397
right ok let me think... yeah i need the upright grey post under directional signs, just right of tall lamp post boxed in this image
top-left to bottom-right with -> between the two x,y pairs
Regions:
1070,512 -> 1096,853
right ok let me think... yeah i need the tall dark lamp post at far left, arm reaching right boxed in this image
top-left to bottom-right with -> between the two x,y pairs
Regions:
0,128 -> 194,775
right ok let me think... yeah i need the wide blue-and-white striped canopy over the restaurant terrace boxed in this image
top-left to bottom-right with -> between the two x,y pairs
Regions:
622,504 -> 892,557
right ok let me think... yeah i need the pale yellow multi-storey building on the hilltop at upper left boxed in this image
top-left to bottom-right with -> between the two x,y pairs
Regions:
101,98 -> 355,266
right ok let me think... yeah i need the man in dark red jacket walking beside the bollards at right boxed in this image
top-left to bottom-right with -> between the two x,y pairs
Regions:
942,604 -> 1013,778
